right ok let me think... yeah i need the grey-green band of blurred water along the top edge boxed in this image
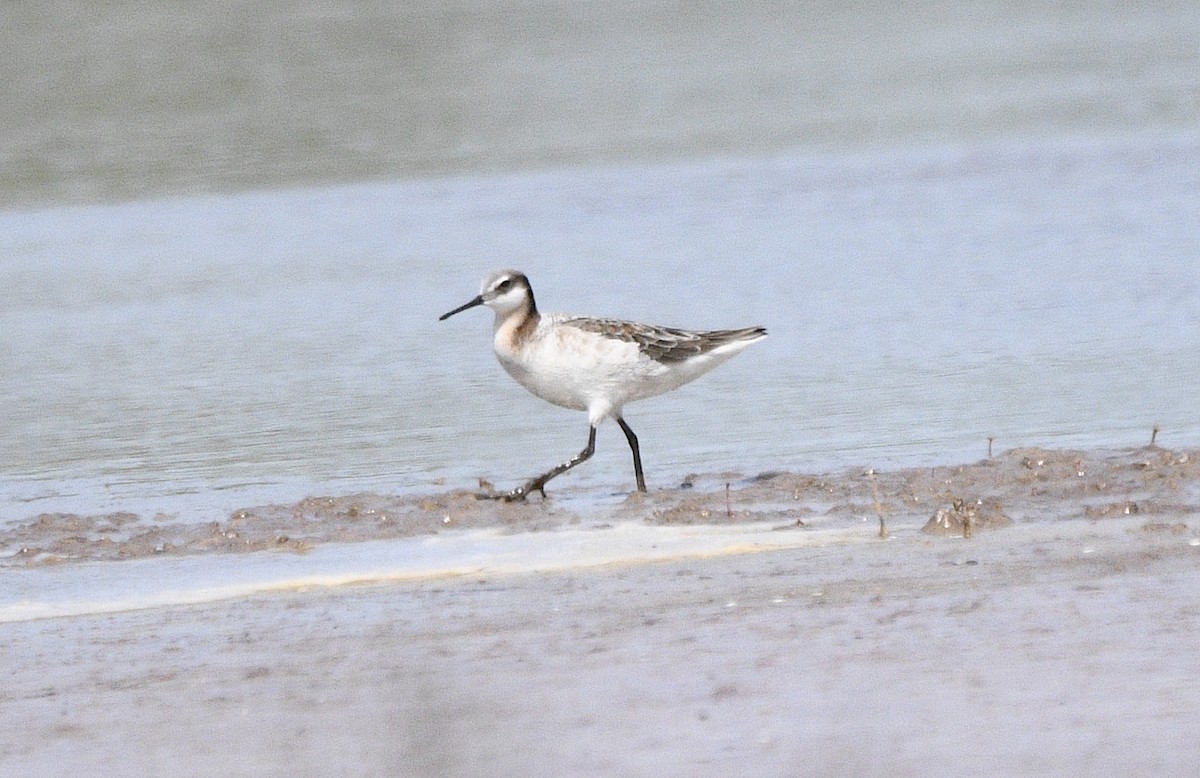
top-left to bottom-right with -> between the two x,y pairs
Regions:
0,0 -> 1200,204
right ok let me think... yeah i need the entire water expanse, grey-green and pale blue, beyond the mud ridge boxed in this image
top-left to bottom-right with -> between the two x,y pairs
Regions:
0,1 -> 1200,521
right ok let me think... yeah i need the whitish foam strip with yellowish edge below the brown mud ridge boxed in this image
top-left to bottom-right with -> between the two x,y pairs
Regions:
0,523 -> 871,623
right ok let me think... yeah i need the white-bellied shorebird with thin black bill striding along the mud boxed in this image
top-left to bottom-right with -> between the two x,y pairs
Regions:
438,270 -> 767,501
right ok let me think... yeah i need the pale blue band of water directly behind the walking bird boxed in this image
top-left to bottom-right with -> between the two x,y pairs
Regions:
0,138 -> 1200,516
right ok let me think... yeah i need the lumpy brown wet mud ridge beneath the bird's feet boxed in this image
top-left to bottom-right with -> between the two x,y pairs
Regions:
0,445 -> 1200,568
